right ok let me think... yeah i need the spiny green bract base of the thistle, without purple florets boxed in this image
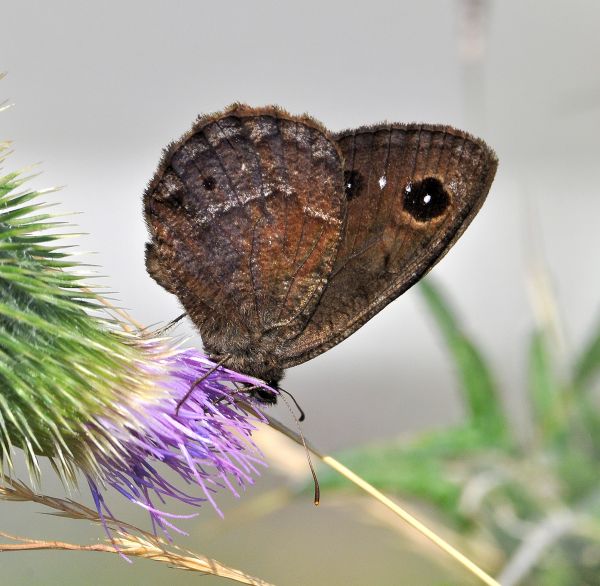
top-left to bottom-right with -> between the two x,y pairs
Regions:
0,144 -> 139,480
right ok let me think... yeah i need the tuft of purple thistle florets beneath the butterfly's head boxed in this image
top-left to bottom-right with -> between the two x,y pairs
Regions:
88,350 -> 272,537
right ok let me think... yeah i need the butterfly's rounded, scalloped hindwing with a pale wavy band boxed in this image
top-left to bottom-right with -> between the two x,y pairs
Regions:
144,106 -> 346,378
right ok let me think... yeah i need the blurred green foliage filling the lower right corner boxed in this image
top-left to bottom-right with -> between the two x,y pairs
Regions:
321,279 -> 600,586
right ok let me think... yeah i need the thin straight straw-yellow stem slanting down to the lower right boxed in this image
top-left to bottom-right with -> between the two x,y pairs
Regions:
264,414 -> 500,586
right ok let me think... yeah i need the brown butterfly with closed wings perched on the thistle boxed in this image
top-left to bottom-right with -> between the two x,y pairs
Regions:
144,104 -> 497,396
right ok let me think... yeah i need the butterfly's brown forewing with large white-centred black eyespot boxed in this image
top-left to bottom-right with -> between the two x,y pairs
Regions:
281,125 -> 497,368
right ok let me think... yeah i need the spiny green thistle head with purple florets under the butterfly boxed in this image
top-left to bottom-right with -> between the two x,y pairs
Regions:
0,144 -> 270,532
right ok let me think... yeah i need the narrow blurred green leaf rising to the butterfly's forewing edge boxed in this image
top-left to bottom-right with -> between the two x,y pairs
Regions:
420,278 -> 509,443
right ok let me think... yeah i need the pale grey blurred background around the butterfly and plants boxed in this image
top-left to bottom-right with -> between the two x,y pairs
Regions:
0,0 -> 600,586
